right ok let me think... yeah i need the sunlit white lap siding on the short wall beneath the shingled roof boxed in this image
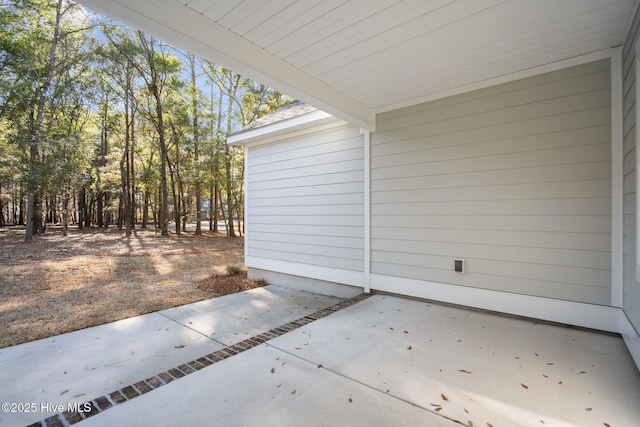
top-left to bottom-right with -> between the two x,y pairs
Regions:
247,127 -> 364,271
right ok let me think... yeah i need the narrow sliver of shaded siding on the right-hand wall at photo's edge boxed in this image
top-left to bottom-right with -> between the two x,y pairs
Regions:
622,7 -> 640,331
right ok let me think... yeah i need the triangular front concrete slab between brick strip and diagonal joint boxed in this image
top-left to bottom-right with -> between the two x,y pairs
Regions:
81,344 -> 452,427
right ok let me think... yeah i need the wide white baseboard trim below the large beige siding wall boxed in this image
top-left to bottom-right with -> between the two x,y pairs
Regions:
371,274 -> 622,333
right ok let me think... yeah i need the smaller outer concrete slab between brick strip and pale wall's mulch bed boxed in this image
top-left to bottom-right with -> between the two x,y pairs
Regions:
159,286 -> 341,348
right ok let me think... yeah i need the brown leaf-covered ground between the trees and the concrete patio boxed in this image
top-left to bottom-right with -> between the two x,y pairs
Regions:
0,228 -> 264,348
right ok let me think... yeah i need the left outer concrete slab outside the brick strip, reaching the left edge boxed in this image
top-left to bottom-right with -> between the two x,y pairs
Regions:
0,313 -> 224,426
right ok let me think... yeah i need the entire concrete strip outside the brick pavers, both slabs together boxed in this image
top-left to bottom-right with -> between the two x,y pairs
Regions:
0,286 -> 340,426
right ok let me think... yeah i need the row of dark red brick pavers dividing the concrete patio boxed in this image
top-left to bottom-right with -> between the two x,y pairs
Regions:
27,294 -> 371,427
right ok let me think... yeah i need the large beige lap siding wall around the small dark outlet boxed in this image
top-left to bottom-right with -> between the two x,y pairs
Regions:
371,60 -> 611,305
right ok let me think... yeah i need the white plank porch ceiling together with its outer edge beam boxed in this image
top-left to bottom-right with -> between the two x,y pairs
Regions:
80,0 -> 634,129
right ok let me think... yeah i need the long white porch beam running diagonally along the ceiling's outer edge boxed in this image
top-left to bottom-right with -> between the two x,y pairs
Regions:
80,0 -> 376,131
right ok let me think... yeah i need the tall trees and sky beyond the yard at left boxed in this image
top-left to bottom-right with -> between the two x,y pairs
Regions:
0,0 -> 291,242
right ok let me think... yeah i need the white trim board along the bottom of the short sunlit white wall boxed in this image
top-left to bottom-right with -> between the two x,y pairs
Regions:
244,256 -> 364,288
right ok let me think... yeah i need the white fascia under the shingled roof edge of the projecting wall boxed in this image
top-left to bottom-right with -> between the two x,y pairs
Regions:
227,110 -> 348,146
